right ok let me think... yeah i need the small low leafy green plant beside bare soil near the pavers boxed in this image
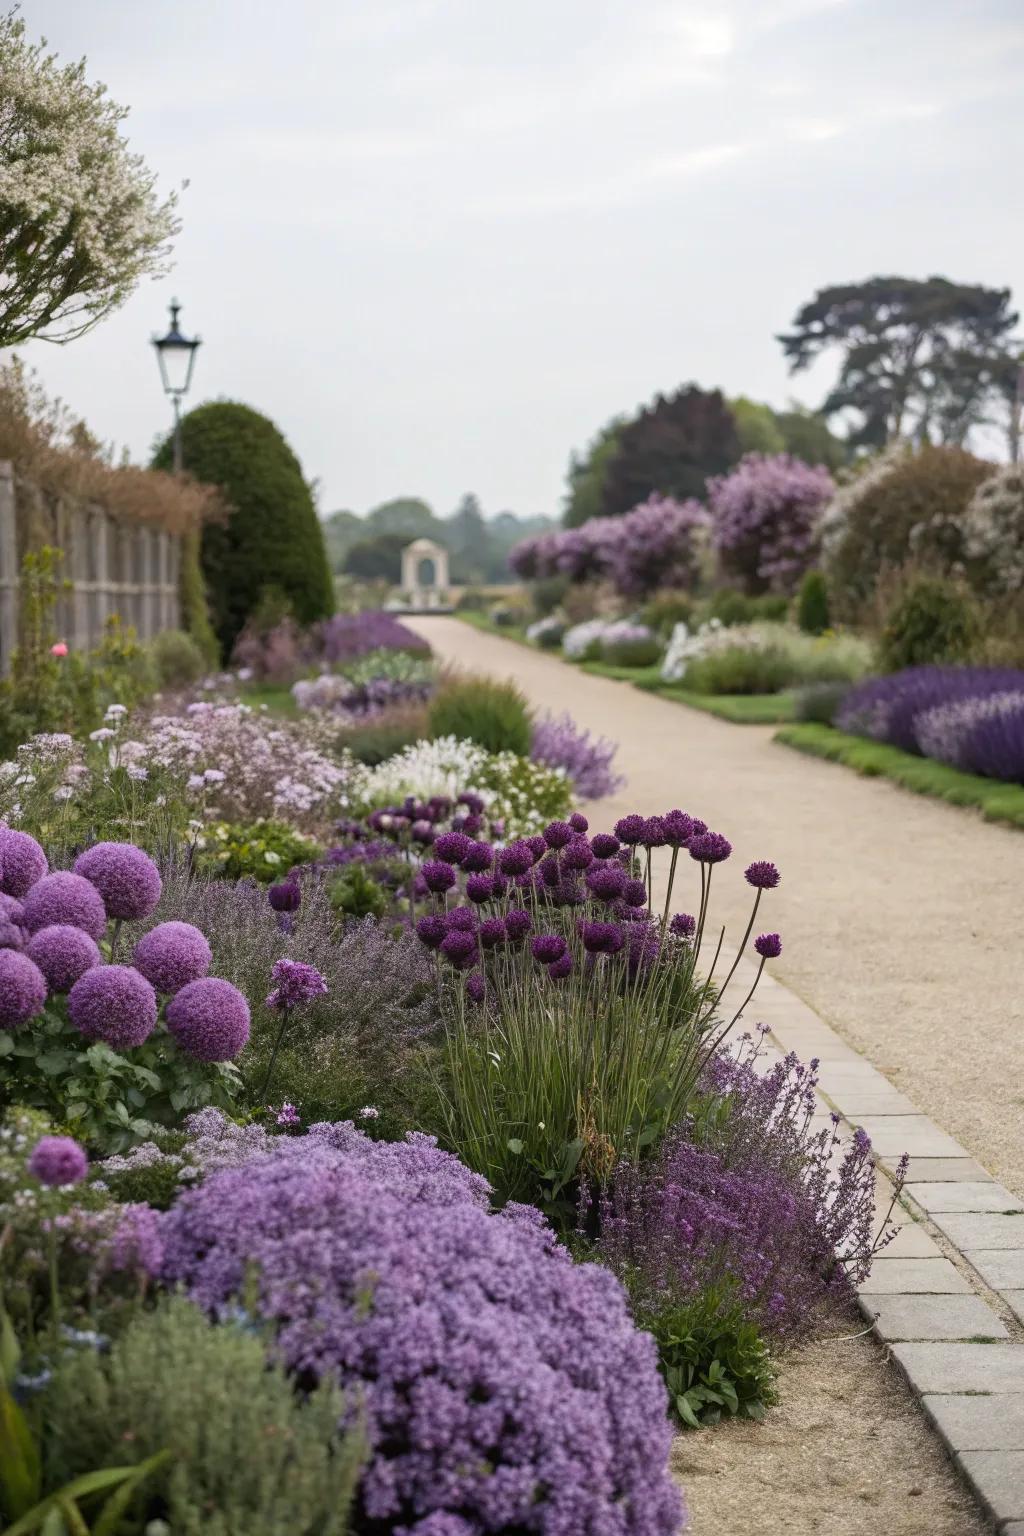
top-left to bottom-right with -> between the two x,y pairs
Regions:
637,1290 -> 777,1428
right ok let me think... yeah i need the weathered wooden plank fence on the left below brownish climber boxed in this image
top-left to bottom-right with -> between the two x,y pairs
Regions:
0,461 -> 181,673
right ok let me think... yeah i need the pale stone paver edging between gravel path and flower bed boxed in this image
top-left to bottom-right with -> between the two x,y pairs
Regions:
748,975 -> 1024,1536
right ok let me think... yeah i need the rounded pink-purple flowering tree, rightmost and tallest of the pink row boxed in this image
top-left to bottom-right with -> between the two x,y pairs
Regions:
708,453 -> 835,593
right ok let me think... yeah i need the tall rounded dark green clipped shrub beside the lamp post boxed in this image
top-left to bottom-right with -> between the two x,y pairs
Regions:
154,401 -> 335,654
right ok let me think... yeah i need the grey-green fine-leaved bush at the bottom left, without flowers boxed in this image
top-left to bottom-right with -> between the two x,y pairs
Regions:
41,1298 -> 364,1536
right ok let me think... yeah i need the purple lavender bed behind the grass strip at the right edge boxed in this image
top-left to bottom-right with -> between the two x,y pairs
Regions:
835,667 -> 1024,783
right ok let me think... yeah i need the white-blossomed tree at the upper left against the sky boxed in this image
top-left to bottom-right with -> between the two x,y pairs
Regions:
0,12 -> 180,347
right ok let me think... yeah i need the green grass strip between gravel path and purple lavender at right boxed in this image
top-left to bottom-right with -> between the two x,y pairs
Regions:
774,722 -> 1024,831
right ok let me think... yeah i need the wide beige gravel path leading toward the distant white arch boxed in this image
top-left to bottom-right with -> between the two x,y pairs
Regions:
410,617 -> 1024,1198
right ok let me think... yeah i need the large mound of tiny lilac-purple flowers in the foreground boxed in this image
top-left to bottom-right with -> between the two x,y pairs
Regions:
160,1124 -> 682,1536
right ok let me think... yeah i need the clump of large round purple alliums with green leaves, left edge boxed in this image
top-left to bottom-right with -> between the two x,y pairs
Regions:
0,828 -> 249,1149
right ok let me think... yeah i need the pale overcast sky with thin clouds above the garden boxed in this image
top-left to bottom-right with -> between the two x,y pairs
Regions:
21,0 -> 1024,513
